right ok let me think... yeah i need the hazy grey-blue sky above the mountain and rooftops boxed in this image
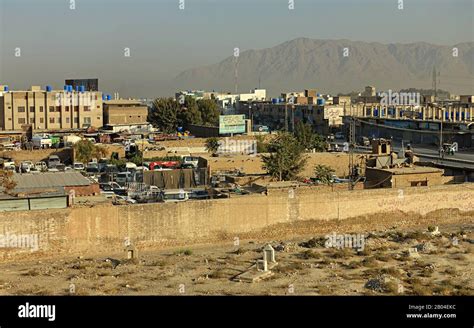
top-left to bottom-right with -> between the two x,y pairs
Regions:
0,0 -> 474,97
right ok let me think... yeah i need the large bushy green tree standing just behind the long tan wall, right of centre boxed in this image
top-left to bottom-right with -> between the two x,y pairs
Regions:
262,132 -> 306,181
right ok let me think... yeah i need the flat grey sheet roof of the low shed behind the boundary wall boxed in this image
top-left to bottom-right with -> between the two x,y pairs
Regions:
13,172 -> 91,190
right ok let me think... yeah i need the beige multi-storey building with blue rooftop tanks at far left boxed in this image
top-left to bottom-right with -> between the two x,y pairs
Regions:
0,86 -> 103,131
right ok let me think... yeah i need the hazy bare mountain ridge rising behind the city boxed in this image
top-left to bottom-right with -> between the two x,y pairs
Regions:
174,38 -> 474,95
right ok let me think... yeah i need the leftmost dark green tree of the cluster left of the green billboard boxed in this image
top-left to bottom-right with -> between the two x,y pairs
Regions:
148,98 -> 180,133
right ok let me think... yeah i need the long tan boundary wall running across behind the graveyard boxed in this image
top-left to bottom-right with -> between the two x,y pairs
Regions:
0,184 -> 474,260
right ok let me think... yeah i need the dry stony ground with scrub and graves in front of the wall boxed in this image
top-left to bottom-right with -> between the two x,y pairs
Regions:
0,211 -> 474,295
